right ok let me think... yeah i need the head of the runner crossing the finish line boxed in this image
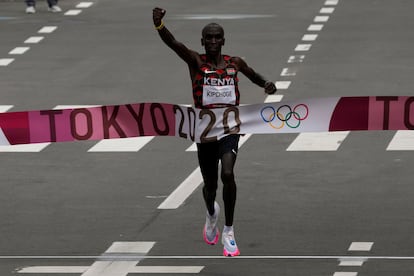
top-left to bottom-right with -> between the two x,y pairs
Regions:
201,23 -> 225,54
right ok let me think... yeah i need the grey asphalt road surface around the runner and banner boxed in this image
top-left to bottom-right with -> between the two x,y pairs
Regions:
0,0 -> 414,276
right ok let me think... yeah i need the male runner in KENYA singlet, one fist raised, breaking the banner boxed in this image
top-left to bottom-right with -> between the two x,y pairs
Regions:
153,8 -> 276,257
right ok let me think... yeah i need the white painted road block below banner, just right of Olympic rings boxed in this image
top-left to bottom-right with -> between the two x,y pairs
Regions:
286,131 -> 349,151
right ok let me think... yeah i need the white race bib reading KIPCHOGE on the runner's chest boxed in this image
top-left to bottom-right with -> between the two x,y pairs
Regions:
203,85 -> 236,106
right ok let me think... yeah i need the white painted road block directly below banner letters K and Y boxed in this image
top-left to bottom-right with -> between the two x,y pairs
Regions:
88,136 -> 154,152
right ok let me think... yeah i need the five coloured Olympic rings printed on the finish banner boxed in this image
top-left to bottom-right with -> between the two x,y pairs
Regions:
260,104 -> 309,129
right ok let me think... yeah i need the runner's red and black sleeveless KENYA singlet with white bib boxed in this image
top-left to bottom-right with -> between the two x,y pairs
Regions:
193,55 -> 240,108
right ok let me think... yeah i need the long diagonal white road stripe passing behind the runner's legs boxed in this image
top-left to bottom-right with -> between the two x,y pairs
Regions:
158,134 -> 251,209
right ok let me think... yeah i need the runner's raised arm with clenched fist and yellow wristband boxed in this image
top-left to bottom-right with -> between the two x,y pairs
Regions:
152,8 -> 198,65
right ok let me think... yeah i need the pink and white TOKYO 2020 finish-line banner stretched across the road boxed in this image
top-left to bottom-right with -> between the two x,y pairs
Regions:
0,96 -> 414,145
